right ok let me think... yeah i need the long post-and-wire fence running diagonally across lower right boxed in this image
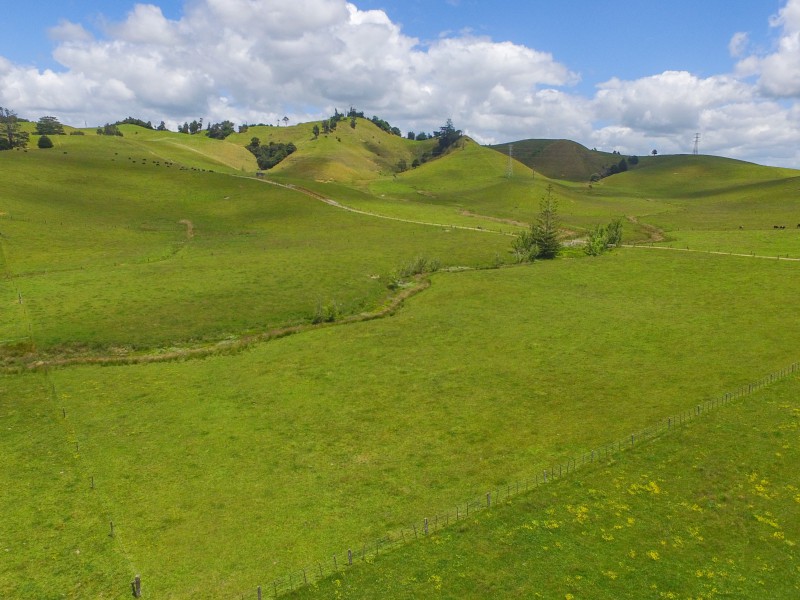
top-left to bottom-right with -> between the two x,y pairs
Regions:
253,362 -> 800,600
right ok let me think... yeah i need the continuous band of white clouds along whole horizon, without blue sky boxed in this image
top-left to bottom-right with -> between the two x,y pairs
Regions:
0,0 -> 800,164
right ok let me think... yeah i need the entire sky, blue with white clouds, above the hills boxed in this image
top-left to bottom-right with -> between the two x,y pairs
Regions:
0,0 -> 800,167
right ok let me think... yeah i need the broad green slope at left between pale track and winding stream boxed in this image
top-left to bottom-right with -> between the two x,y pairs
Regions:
0,133 -> 509,360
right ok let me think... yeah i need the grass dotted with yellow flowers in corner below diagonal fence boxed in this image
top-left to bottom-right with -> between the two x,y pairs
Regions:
291,377 -> 800,599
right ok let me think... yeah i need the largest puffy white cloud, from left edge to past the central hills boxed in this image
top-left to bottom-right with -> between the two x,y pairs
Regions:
0,0 -> 578,127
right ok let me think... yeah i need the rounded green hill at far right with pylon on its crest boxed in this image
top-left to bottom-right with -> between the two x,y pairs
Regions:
591,155 -> 800,248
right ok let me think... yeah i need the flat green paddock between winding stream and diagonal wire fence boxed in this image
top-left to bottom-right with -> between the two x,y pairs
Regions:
3,250 -> 800,597
